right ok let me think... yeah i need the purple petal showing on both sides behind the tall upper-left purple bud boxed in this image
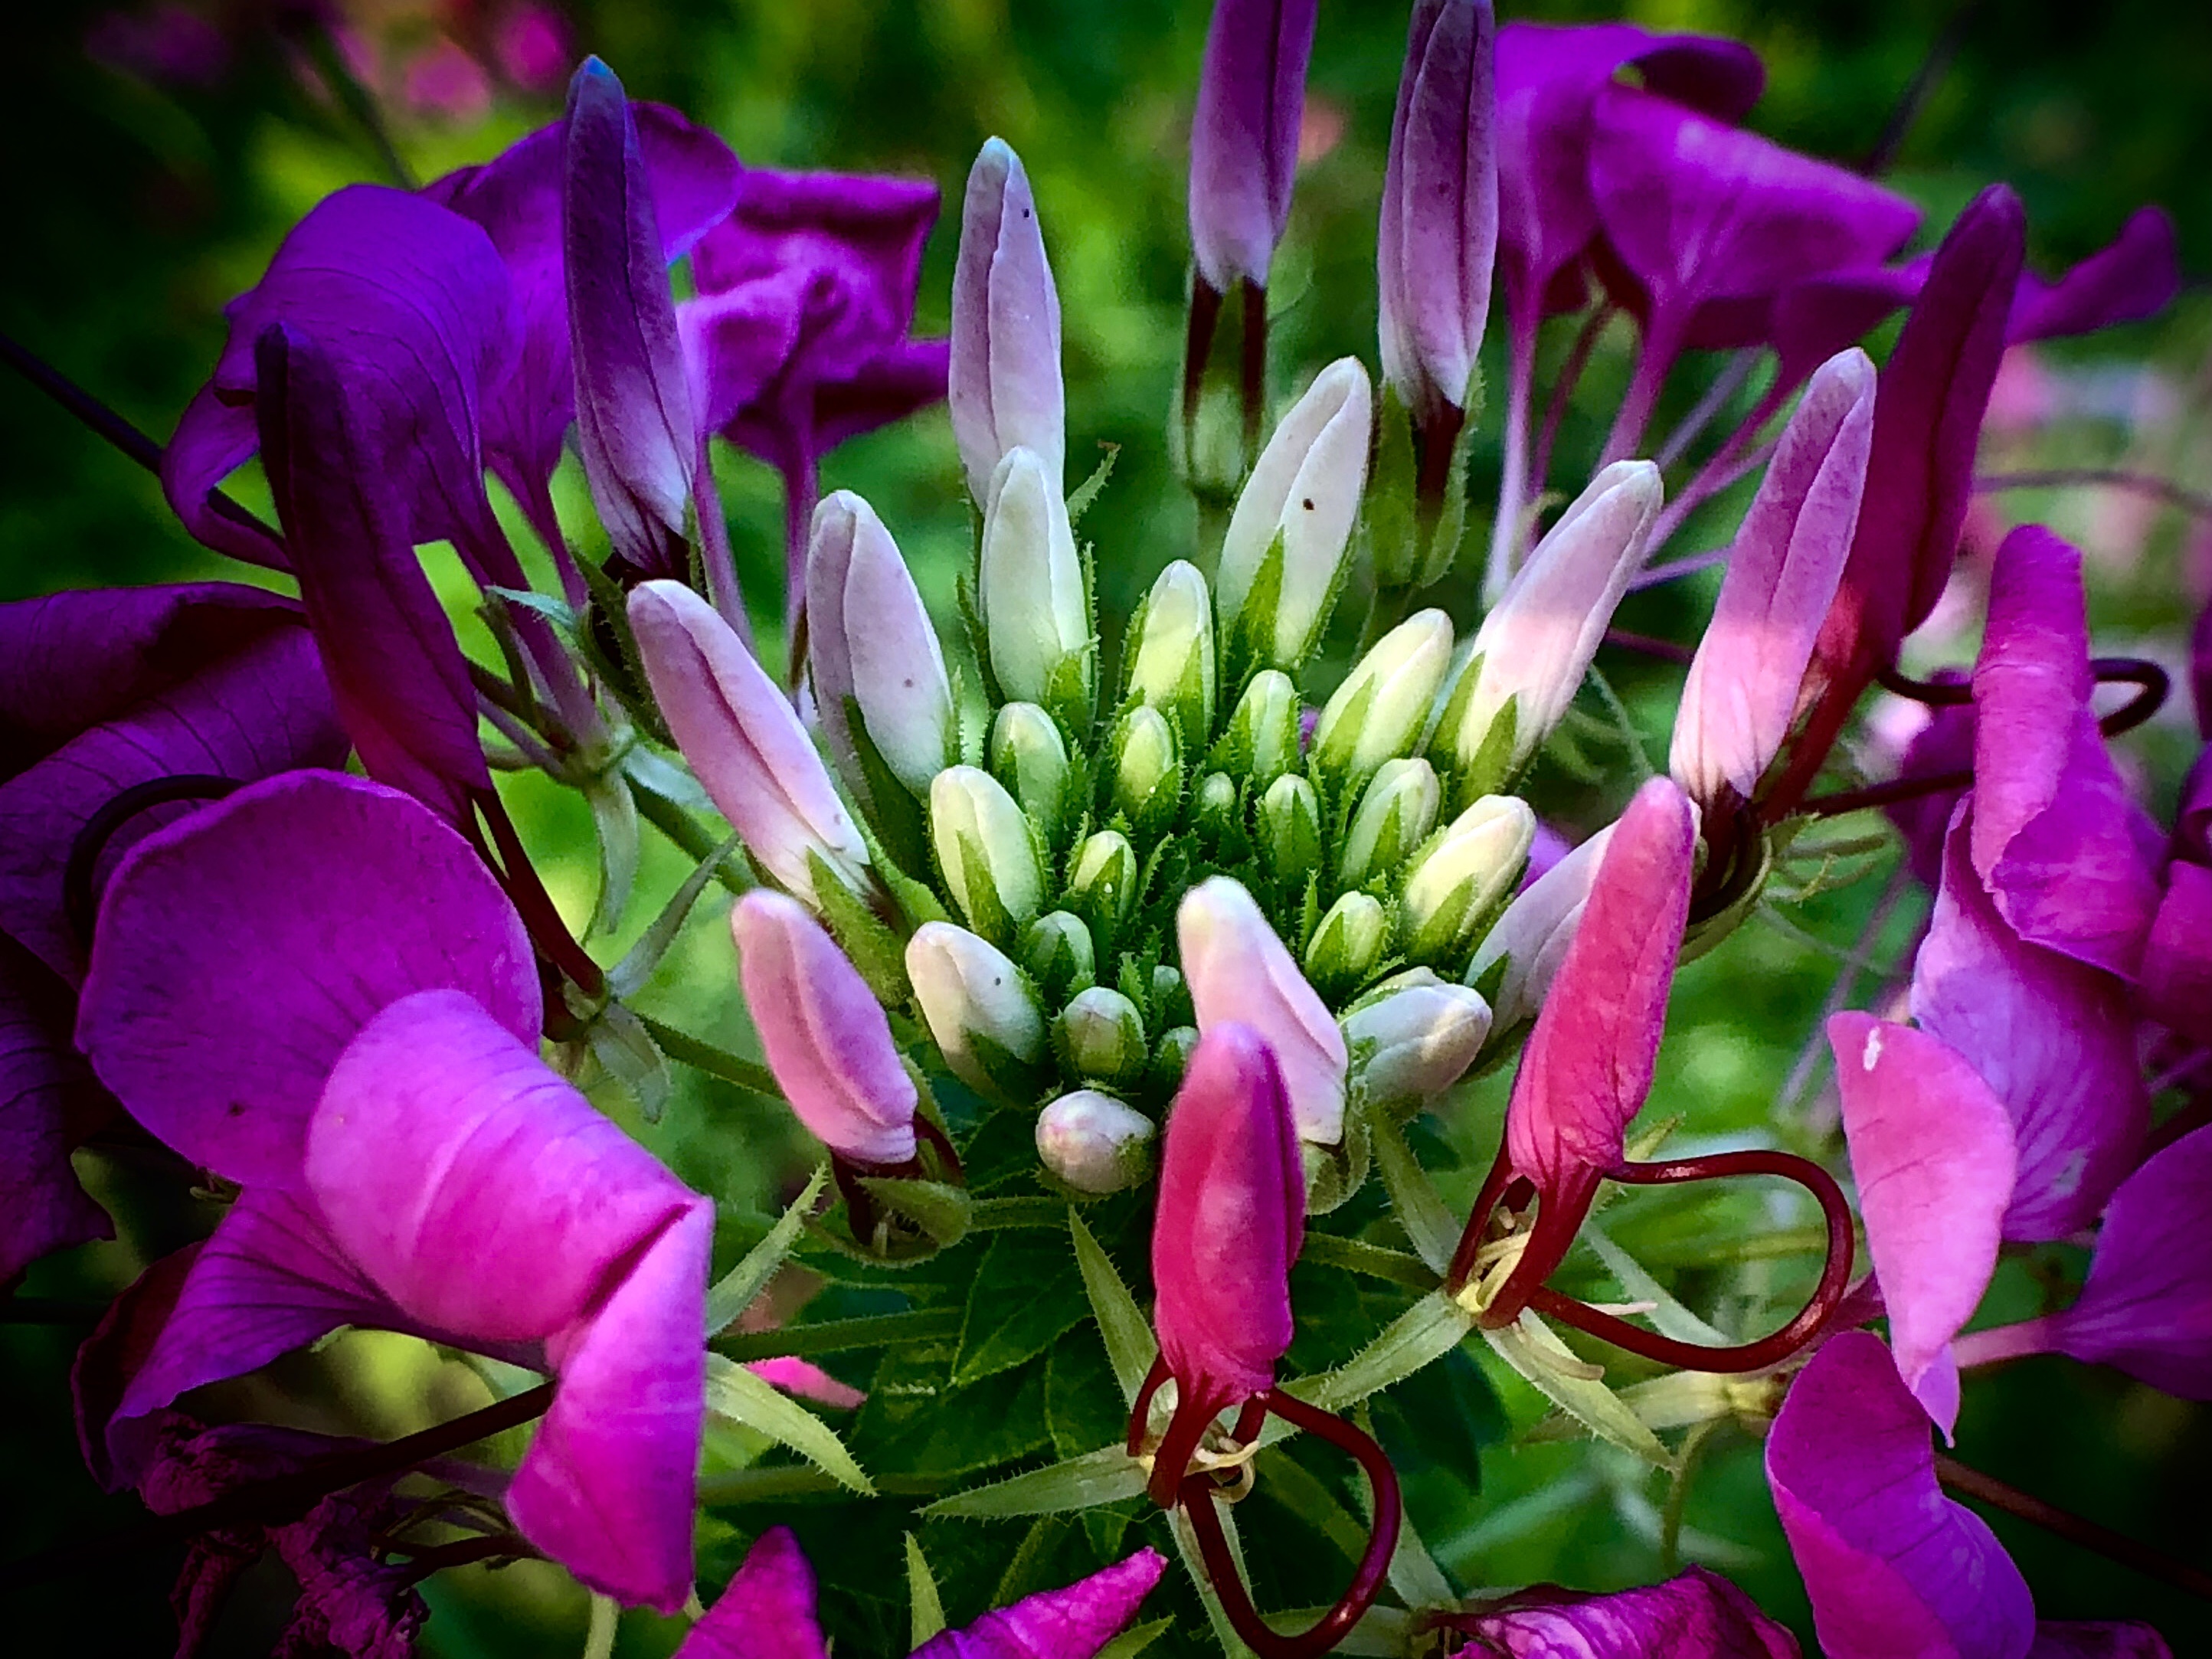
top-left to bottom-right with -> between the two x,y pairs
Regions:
423,102 -> 741,511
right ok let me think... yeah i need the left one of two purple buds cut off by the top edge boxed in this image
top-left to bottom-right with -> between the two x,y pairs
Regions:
1190,0 -> 1320,294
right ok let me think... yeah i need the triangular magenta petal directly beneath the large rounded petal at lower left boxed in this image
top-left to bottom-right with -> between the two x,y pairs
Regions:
109,1188 -> 404,1447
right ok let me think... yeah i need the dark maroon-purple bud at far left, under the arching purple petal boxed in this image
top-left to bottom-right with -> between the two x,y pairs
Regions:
257,327 -> 491,825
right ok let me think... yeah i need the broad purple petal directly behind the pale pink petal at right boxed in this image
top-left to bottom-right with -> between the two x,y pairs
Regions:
1913,805 -> 2150,1241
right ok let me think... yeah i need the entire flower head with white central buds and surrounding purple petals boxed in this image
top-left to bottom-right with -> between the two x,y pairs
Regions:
0,0 -> 2212,1659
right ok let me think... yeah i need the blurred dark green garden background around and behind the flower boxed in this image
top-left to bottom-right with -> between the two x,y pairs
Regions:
0,0 -> 2212,1654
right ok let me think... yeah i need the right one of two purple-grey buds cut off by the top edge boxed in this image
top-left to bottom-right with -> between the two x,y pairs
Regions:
1376,0 -> 1497,416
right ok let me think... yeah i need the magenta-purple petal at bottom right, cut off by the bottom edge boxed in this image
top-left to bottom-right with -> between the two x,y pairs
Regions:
1768,1332 -> 2035,1659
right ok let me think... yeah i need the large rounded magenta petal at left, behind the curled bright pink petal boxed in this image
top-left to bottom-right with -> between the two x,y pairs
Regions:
77,772 -> 542,1188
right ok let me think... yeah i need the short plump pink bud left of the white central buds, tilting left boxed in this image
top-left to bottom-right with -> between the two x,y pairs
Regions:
730,892 -> 918,1166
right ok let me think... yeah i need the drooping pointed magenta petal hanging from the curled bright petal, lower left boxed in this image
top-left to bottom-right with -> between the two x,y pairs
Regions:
506,1203 -> 715,1615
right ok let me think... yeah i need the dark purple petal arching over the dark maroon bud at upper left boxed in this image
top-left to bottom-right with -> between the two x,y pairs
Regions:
164,184 -> 520,582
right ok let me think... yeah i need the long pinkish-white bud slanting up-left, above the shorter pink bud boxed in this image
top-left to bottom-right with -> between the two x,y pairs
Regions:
630,582 -> 869,900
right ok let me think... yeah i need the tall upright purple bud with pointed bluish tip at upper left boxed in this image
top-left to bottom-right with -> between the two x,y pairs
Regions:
562,57 -> 699,578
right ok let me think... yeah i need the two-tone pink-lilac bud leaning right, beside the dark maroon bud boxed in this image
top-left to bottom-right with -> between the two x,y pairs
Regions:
1670,347 -> 1873,803
